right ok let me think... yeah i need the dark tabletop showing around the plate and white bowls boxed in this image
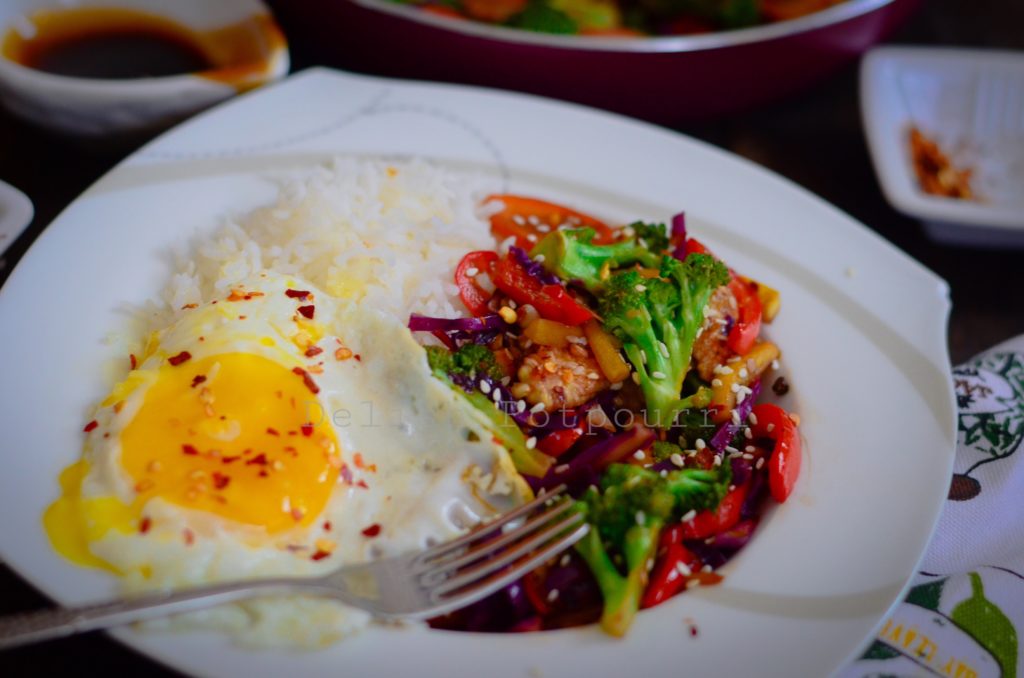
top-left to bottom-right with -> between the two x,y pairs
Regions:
0,0 -> 1024,676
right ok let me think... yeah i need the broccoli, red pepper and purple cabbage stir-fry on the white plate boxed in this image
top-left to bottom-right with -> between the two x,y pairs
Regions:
409,195 -> 802,635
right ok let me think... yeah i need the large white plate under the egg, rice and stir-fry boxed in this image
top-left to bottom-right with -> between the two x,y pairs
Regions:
0,70 -> 955,678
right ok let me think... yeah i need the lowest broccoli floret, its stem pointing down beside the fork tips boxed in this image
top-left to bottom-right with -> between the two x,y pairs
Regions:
575,464 -> 732,636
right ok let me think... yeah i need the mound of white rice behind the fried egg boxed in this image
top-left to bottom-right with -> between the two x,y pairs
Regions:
152,158 -> 495,326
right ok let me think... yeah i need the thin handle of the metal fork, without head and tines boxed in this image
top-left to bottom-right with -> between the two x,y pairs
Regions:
0,580 -> 297,649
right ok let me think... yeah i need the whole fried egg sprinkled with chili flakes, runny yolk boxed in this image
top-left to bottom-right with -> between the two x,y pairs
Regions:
44,271 -> 528,645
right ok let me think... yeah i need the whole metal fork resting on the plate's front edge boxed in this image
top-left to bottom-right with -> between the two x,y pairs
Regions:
0,486 -> 588,649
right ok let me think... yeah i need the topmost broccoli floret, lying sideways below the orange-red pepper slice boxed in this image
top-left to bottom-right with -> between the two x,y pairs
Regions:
529,224 -> 668,292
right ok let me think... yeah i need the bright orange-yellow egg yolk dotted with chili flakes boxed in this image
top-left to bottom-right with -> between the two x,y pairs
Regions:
121,353 -> 341,533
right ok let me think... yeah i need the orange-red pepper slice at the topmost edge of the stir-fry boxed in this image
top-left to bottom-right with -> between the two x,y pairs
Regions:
484,195 -> 616,251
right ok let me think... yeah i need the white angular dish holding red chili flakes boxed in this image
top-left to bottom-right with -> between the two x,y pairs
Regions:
860,47 -> 1024,247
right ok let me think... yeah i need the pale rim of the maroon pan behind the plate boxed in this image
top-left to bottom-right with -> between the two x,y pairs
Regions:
350,0 -> 895,53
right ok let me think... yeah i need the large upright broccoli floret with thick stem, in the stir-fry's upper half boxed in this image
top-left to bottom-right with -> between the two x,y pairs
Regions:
600,254 -> 729,427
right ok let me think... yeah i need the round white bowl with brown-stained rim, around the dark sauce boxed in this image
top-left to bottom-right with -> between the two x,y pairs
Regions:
0,0 -> 289,137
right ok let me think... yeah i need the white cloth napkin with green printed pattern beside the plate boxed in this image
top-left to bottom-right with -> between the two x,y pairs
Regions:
840,336 -> 1024,678
